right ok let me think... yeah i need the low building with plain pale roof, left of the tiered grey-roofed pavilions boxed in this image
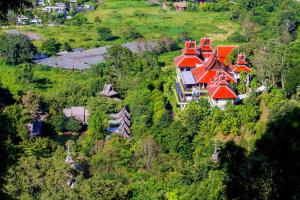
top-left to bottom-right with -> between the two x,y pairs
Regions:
63,106 -> 90,124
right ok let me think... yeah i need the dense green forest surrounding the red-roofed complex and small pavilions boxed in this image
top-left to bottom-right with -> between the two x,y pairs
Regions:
0,0 -> 300,200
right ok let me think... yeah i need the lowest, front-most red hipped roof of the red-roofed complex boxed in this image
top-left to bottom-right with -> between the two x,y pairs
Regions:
207,80 -> 238,99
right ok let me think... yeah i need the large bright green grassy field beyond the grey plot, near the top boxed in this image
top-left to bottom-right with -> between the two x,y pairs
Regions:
2,0 -> 239,48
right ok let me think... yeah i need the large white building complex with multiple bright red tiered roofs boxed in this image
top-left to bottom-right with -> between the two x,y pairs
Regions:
174,38 -> 251,109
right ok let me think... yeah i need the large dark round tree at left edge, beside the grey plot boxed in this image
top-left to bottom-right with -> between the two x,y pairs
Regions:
0,34 -> 36,65
